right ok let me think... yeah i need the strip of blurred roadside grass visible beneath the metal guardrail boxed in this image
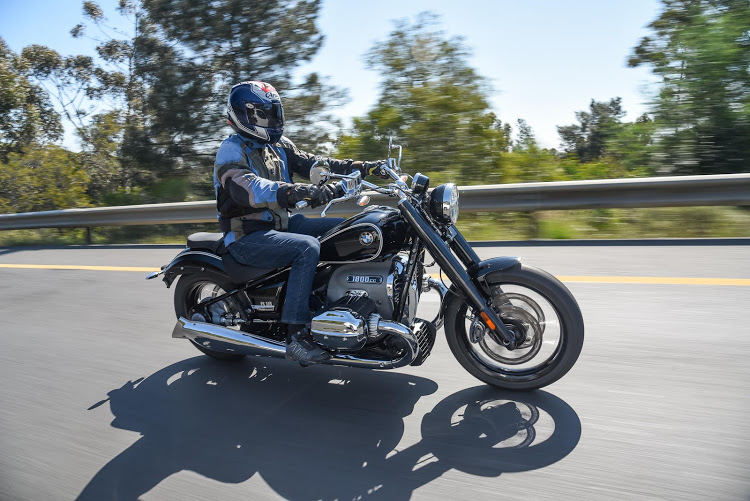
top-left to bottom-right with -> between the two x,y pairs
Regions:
0,207 -> 750,247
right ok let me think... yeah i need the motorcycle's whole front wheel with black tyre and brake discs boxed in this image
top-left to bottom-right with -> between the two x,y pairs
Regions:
445,265 -> 583,390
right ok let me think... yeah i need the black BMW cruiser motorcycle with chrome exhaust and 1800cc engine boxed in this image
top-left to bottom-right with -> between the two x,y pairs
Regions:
146,141 -> 584,390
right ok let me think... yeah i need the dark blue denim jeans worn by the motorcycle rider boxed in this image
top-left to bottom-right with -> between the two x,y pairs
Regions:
227,214 -> 343,324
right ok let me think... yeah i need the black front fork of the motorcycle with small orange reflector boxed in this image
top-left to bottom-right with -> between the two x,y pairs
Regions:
398,200 -> 517,350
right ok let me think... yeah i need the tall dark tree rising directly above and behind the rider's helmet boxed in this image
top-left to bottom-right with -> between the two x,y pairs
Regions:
143,0 -> 346,151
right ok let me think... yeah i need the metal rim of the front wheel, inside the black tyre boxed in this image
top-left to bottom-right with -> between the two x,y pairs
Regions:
456,283 -> 566,381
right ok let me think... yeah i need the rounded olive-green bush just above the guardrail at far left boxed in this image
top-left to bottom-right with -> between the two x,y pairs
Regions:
0,146 -> 90,212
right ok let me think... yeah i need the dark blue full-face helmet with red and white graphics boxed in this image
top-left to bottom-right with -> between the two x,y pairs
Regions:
227,81 -> 284,143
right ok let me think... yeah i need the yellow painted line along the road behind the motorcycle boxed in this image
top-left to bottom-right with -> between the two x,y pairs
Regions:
0,263 -> 750,287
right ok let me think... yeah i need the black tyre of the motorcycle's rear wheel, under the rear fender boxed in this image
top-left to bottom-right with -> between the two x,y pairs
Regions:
174,272 -> 245,362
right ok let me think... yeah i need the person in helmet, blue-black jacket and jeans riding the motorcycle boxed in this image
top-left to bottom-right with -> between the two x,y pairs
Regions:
214,81 -> 383,363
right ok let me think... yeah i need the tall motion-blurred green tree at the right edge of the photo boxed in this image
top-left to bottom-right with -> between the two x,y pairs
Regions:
629,0 -> 750,174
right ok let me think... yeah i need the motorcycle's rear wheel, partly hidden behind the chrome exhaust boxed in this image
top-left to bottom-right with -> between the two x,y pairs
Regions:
174,273 -> 245,360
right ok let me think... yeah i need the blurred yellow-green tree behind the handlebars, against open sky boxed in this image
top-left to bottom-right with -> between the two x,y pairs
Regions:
337,14 -> 508,184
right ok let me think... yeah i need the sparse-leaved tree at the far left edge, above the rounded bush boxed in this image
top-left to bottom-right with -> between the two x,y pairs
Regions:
0,38 -> 62,162
